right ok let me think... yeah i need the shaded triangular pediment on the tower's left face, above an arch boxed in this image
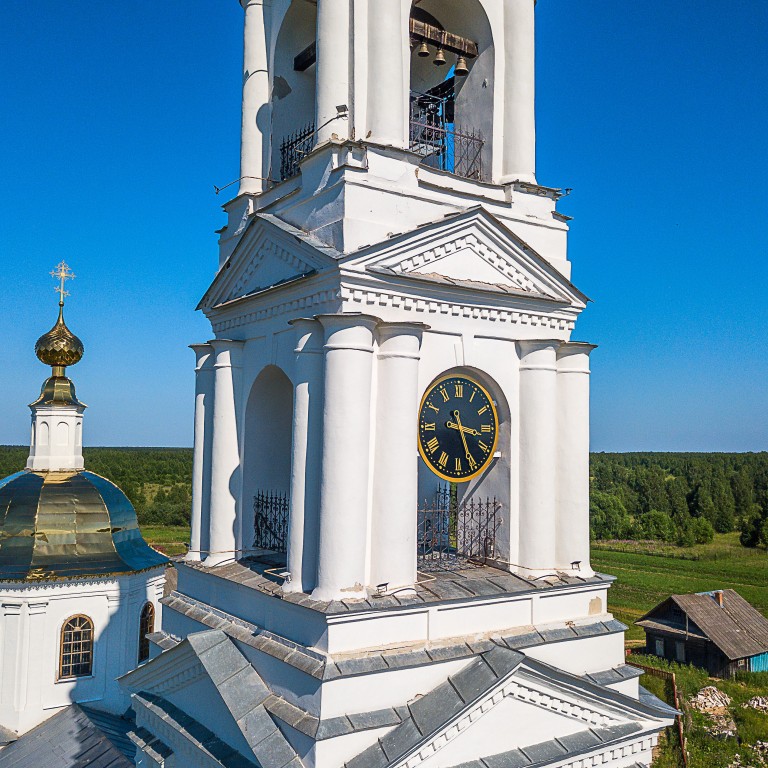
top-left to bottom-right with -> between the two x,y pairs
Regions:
198,215 -> 334,309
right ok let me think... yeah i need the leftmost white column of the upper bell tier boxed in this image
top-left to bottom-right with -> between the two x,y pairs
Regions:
239,0 -> 271,195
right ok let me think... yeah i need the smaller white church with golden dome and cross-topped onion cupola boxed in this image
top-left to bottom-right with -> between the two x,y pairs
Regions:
0,262 -> 168,768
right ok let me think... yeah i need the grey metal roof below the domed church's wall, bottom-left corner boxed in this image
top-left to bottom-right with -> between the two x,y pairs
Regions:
0,704 -> 135,768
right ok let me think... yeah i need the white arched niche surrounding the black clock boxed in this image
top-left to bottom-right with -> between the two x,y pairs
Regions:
419,366 -> 512,544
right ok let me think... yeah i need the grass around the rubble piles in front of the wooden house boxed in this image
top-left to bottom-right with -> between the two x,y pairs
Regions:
629,654 -> 768,768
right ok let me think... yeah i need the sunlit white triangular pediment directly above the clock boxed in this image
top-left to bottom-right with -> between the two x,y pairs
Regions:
348,208 -> 588,308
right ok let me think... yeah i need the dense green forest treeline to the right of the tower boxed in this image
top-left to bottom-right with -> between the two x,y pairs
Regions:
590,453 -> 768,547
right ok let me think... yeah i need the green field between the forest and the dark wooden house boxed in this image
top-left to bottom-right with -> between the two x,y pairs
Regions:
592,533 -> 768,645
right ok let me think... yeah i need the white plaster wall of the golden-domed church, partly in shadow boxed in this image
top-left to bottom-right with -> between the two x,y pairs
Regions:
0,570 -> 165,733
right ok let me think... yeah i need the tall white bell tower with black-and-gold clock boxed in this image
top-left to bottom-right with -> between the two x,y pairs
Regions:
120,0 -> 674,768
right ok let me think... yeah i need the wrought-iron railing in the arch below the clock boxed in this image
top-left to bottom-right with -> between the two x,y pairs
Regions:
417,486 -> 501,571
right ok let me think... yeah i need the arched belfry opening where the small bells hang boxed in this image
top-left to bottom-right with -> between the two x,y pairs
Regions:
410,0 -> 496,181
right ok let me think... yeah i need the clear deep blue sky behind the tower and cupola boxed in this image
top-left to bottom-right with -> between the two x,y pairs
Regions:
0,0 -> 768,451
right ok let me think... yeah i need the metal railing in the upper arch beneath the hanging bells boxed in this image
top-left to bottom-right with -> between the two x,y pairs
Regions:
409,91 -> 484,181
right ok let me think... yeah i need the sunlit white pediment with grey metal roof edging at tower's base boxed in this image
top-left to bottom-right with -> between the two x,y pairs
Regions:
347,648 -> 672,768
